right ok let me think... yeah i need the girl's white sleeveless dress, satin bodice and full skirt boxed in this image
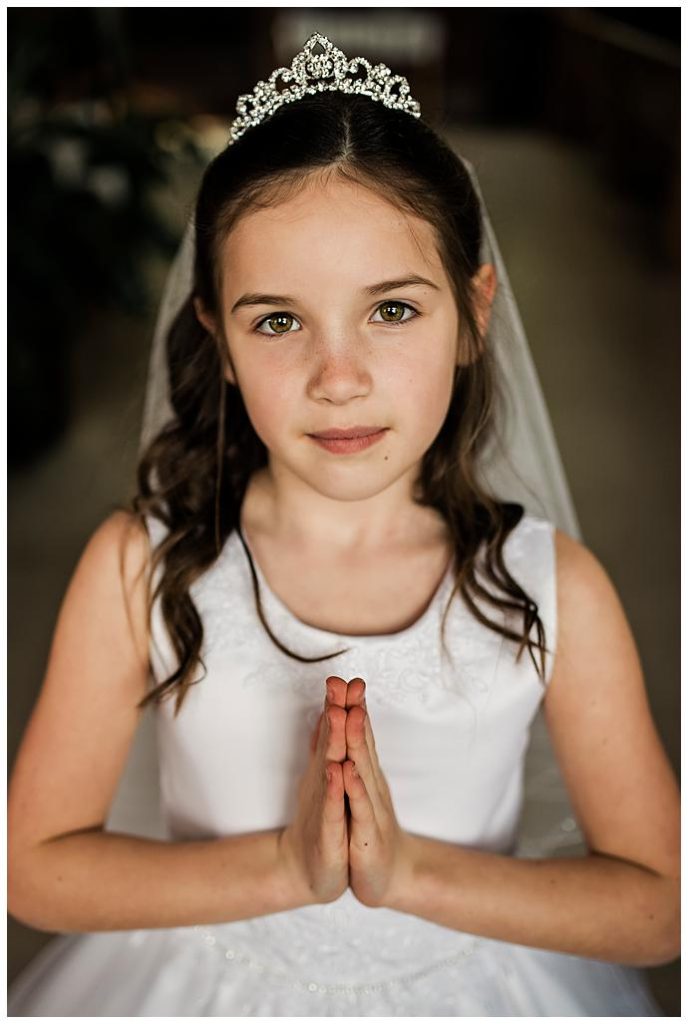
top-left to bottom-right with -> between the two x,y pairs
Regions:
8,514 -> 664,1017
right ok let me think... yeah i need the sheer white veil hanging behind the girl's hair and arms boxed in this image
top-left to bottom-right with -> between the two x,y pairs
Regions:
108,142 -> 585,856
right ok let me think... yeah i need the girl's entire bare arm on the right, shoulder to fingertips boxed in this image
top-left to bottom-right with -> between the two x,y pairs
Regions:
344,531 -> 680,967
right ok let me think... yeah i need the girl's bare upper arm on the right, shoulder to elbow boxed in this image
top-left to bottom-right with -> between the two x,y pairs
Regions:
544,529 -> 680,878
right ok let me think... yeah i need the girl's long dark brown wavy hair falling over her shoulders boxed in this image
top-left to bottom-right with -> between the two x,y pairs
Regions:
129,92 -> 548,715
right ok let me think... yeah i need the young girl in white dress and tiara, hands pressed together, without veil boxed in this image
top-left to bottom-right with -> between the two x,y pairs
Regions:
9,37 -> 679,1016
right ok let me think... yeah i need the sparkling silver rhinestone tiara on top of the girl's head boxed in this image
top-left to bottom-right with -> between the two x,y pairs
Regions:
227,32 -> 421,145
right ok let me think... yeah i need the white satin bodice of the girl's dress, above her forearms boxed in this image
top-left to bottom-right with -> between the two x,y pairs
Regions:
148,515 -> 556,853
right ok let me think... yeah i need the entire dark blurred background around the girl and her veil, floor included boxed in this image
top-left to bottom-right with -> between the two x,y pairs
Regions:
7,7 -> 680,1016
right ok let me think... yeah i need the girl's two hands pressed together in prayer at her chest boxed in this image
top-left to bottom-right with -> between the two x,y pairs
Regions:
281,676 -> 409,906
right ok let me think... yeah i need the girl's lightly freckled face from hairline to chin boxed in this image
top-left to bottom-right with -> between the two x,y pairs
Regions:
197,169 -> 489,528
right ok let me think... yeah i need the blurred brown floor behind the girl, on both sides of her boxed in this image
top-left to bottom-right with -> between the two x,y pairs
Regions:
8,128 -> 680,1016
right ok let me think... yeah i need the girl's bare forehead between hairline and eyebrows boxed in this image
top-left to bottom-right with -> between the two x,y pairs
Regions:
222,180 -> 443,292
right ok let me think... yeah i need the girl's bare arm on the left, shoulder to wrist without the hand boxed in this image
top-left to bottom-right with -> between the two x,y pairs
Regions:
8,513 -> 337,932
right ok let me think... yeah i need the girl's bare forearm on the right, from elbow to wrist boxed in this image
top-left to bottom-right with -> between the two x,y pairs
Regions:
389,836 -> 680,967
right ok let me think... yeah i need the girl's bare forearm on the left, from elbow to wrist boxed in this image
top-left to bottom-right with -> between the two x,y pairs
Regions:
8,829 -> 305,932
